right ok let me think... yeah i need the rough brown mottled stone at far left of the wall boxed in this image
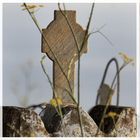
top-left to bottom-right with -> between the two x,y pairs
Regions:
3,107 -> 49,137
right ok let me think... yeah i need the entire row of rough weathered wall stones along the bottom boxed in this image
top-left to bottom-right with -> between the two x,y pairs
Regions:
3,105 -> 137,137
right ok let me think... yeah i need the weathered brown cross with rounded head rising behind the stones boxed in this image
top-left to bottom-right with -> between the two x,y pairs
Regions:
42,11 -> 87,103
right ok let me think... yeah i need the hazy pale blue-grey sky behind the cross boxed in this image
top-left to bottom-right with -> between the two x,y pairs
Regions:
3,3 -> 136,110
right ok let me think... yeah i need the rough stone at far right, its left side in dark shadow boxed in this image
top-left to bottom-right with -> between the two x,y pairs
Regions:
89,105 -> 136,137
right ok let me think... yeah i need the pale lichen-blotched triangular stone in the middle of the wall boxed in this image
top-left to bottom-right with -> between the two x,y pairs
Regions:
53,108 -> 103,137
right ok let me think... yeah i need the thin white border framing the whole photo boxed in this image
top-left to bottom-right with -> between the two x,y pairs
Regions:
0,0 -> 140,139
